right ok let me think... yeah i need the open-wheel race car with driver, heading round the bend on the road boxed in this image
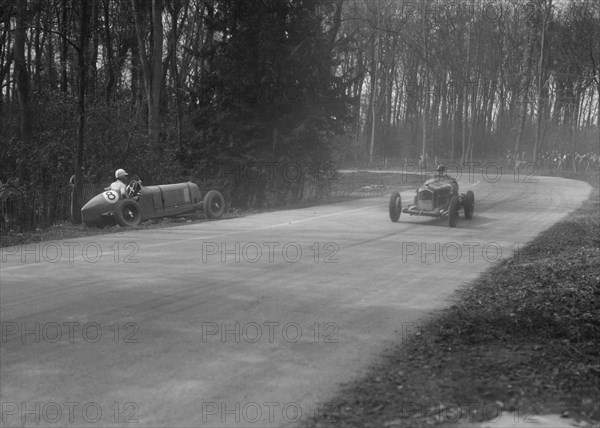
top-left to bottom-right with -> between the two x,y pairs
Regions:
389,165 -> 475,227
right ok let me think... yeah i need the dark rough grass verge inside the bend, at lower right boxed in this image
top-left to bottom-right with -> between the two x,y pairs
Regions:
307,176 -> 600,428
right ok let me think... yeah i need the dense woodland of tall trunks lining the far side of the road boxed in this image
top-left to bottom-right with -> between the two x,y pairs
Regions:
0,0 -> 600,224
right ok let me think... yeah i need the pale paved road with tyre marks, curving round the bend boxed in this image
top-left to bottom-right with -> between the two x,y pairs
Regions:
0,175 -> 590,427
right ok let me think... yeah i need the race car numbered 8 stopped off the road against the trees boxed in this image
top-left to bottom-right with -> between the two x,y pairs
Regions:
81,177 -> 225,227
